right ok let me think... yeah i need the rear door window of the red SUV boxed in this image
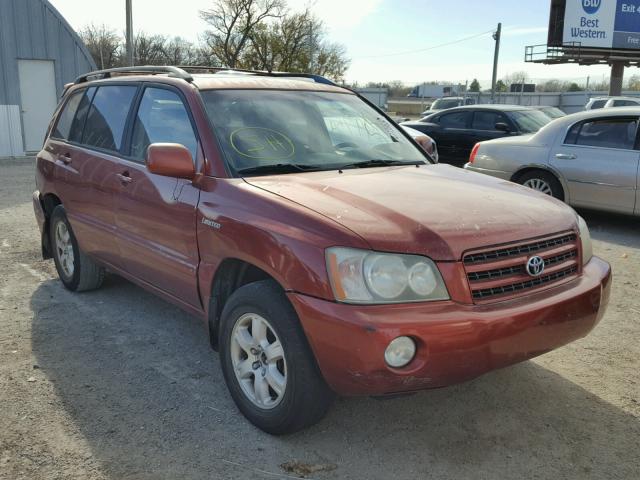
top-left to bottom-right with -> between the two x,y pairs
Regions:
82,85 -> 137,151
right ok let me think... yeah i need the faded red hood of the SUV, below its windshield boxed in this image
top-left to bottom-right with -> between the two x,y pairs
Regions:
245,165 -> 576,261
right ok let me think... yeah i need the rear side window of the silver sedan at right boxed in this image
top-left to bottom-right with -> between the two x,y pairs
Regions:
565,117 -> 638,150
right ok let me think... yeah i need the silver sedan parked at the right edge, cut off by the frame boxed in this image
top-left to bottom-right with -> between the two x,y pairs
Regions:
465,107 -> 640,215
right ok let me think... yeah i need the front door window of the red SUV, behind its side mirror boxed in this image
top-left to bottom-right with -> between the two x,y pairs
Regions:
131,88 -> 198,159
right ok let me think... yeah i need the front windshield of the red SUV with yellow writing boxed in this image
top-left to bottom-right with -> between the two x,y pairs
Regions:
202,90 -> 426,175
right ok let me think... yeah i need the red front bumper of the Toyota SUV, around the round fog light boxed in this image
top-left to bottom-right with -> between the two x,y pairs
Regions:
289,257 -> 611,395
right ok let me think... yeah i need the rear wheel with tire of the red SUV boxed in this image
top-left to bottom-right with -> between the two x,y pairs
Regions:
49,205 -> 104,292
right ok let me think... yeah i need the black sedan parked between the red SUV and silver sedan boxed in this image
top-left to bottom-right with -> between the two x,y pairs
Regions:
402,105 -> 551,167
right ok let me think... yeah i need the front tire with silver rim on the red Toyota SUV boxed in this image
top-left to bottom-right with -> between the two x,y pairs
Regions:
220,280 -> 334,435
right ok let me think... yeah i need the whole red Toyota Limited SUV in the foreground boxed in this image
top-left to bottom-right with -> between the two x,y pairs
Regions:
33,67 -> 610,434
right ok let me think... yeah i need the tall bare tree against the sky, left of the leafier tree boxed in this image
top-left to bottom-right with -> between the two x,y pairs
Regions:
200,0 -> 284,68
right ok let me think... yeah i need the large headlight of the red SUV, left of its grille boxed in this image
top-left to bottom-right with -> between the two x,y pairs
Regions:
326,247 -> 449,303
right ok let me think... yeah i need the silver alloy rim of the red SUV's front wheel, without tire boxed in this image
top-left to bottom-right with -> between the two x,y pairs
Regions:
230,313 -> 287,410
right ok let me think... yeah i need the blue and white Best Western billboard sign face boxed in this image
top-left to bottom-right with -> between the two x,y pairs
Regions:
562,0 -> 640,49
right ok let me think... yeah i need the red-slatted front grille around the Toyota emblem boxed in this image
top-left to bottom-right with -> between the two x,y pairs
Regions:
463,233 -> 580,302
